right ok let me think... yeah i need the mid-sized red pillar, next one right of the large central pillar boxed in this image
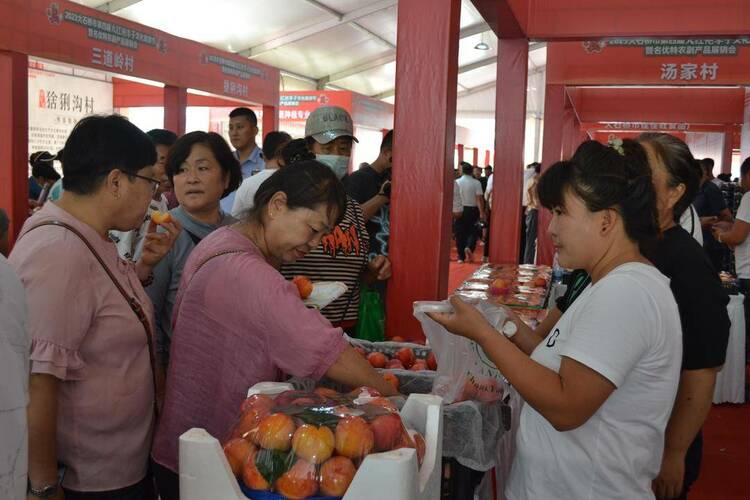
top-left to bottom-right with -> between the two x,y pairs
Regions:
490,38 -> 532,264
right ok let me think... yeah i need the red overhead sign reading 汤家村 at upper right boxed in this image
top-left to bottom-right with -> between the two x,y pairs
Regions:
547,37 -> 750,85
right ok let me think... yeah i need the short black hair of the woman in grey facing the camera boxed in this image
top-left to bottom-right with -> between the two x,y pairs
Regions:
164,130 -> 242,198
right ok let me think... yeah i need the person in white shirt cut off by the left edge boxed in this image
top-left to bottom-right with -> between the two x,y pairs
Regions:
0,256 -> 31,500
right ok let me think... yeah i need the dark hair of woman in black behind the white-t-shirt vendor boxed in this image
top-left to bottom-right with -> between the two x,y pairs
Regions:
636,132 -> 703,222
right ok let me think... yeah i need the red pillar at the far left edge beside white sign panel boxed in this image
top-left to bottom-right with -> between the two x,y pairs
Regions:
0,51 -> 29,245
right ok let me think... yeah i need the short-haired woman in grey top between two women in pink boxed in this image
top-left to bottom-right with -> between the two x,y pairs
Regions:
146,131 -> 242,367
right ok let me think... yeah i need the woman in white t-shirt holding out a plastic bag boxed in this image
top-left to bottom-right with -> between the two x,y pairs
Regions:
433,140 -> 682,500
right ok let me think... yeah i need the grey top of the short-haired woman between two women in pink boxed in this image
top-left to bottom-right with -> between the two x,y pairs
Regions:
146,206 -> 236,365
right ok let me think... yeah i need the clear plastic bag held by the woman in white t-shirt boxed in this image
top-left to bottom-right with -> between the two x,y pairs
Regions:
414,301 -> 508,403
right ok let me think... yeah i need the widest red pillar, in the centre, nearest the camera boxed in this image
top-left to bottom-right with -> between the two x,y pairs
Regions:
386,0 -> 461,339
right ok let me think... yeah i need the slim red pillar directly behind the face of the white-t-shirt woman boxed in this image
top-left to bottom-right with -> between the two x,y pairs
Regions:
536,85 -> 567,265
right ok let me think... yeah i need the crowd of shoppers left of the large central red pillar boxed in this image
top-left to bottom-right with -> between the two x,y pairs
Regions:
0,106 -> 394,500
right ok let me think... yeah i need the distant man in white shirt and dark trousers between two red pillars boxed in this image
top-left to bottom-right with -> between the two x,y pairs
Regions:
456,162 -> 487,264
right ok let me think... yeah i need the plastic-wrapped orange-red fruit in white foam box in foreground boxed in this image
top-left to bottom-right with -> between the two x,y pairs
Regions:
223,387 -> 425,499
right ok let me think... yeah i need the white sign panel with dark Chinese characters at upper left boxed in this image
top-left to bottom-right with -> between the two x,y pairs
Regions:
29,68 -> 113,154
